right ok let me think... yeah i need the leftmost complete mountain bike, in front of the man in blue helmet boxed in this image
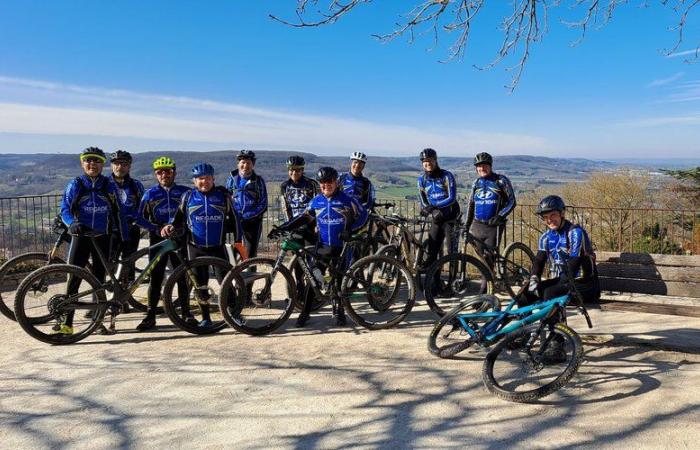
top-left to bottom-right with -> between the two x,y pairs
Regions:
15,230 -> 231,345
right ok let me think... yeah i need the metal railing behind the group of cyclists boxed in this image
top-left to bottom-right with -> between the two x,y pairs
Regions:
0,195 -> 700,260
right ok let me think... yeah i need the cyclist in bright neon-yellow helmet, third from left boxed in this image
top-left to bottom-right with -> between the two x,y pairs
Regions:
136,156 -> 189,331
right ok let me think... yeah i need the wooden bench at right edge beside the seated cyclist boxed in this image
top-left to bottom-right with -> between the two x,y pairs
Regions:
597,252 -> 700,317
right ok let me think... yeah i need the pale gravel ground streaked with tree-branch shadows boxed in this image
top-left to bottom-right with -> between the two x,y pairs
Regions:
0,302 -> 700,449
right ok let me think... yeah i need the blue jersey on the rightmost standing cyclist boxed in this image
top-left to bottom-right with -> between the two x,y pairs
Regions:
467,173 -> 515,225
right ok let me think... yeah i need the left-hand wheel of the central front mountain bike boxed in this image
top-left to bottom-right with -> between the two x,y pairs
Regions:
219,257 -> 297,336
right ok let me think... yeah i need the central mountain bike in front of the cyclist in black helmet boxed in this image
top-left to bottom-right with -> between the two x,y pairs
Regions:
220,232 -> 415,335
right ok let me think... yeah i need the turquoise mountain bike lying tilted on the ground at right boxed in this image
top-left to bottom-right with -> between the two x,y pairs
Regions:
428,251 -> 593,402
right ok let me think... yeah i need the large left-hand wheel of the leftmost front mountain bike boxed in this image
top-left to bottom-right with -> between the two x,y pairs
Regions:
14,264 -> 107,345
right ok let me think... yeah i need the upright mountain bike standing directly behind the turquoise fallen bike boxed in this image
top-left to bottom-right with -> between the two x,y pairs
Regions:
424,229 -> 535,316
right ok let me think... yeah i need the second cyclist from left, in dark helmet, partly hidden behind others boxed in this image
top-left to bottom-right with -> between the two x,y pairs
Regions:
110,150 -> 144,290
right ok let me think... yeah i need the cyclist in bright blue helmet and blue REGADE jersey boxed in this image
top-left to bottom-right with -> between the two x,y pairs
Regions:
161,163 -> 241,327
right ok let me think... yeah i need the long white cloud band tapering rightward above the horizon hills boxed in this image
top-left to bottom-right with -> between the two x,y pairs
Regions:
0,77 -> 550,155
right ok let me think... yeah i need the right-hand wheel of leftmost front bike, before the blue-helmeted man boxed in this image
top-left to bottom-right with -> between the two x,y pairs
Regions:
162,256 -> 231,334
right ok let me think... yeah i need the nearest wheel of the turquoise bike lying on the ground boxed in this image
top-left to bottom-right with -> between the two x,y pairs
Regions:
482,322 -> 583,403
